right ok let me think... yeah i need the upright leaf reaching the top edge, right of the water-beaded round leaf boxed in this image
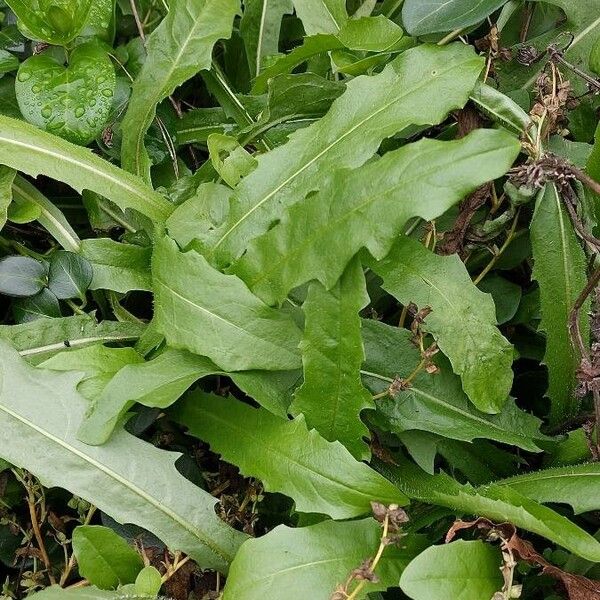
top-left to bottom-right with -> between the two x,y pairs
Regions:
121,0 -> 240,183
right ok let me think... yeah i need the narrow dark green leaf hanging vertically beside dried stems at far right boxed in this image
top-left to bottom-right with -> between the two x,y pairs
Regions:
530,184 -> 589,424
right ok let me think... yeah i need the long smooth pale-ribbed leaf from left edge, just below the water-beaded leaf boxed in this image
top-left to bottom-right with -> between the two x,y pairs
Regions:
0,116 -> 173,223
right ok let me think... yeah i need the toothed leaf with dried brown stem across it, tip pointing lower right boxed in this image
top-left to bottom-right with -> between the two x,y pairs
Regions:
362,320 -> 549,452
